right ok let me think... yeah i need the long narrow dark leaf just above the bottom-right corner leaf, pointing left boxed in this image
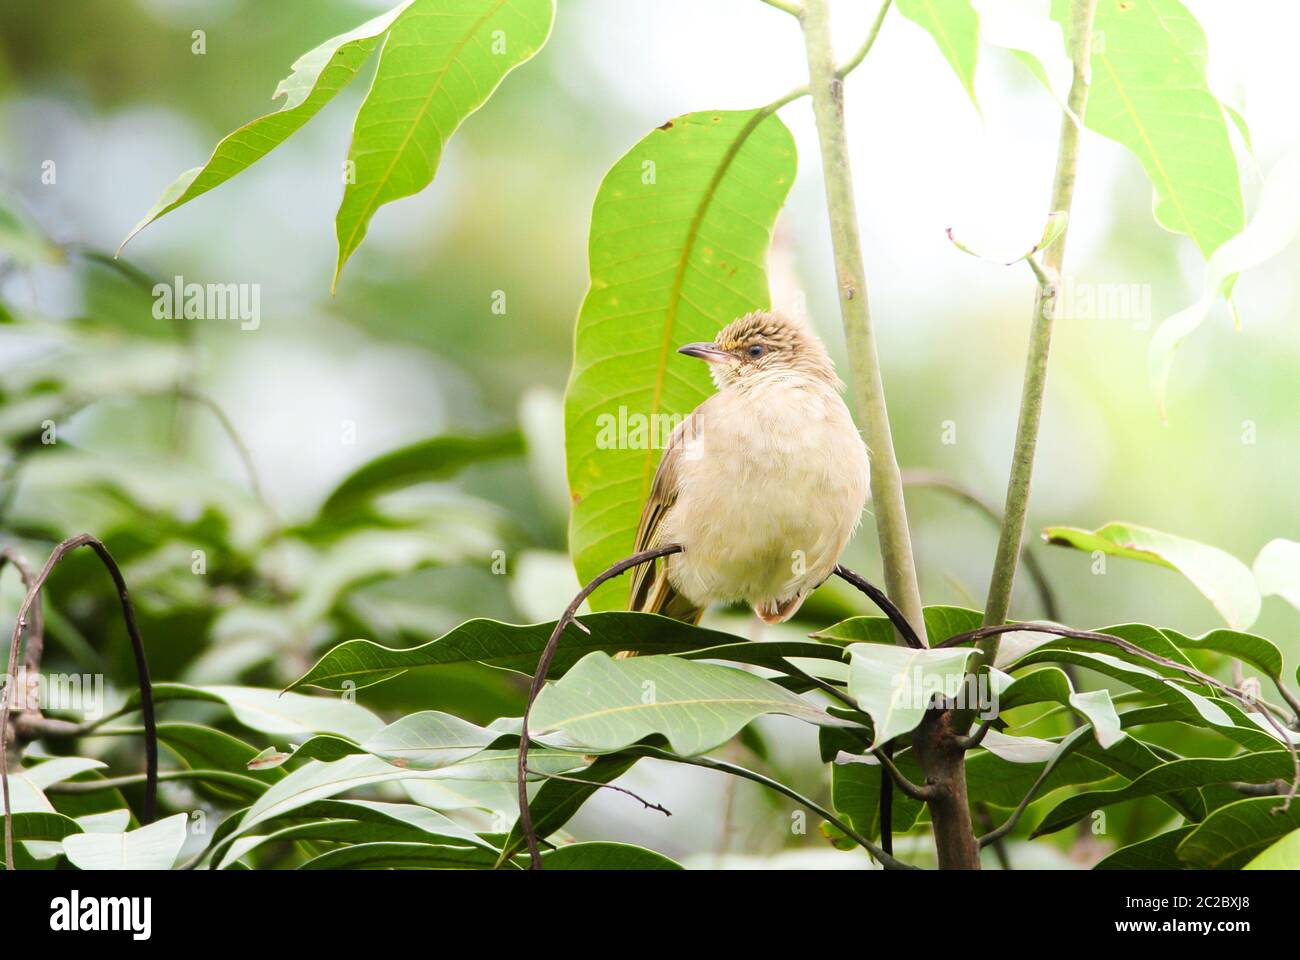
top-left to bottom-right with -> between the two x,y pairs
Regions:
1034,751 -> 1292,836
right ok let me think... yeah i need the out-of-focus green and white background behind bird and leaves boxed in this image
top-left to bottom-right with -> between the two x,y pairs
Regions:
0,0 -> 1300,866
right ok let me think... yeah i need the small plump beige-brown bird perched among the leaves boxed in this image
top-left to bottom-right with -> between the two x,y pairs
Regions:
628,311 -> 870,623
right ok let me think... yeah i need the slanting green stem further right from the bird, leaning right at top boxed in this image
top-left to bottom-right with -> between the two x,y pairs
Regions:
979,0 -> 1097,647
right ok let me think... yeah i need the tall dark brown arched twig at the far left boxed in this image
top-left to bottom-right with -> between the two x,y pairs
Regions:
0,533 -> 159,870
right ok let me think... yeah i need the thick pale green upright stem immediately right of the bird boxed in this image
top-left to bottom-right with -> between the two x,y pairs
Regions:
801,0 -> 924,640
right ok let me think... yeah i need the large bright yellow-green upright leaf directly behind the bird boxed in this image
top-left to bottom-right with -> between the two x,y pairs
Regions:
564,109 -> 794,610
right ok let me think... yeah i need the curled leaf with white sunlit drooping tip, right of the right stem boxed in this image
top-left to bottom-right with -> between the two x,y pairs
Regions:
1043,522 -> 1260,630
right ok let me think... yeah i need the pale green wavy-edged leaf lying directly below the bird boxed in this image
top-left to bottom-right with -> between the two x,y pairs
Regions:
532,653 -> 852,757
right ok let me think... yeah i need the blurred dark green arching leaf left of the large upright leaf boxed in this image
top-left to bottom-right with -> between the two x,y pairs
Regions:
317,431 -> 524,523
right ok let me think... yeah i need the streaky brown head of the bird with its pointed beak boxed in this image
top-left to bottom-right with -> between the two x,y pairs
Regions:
677,310 -> 842,389
